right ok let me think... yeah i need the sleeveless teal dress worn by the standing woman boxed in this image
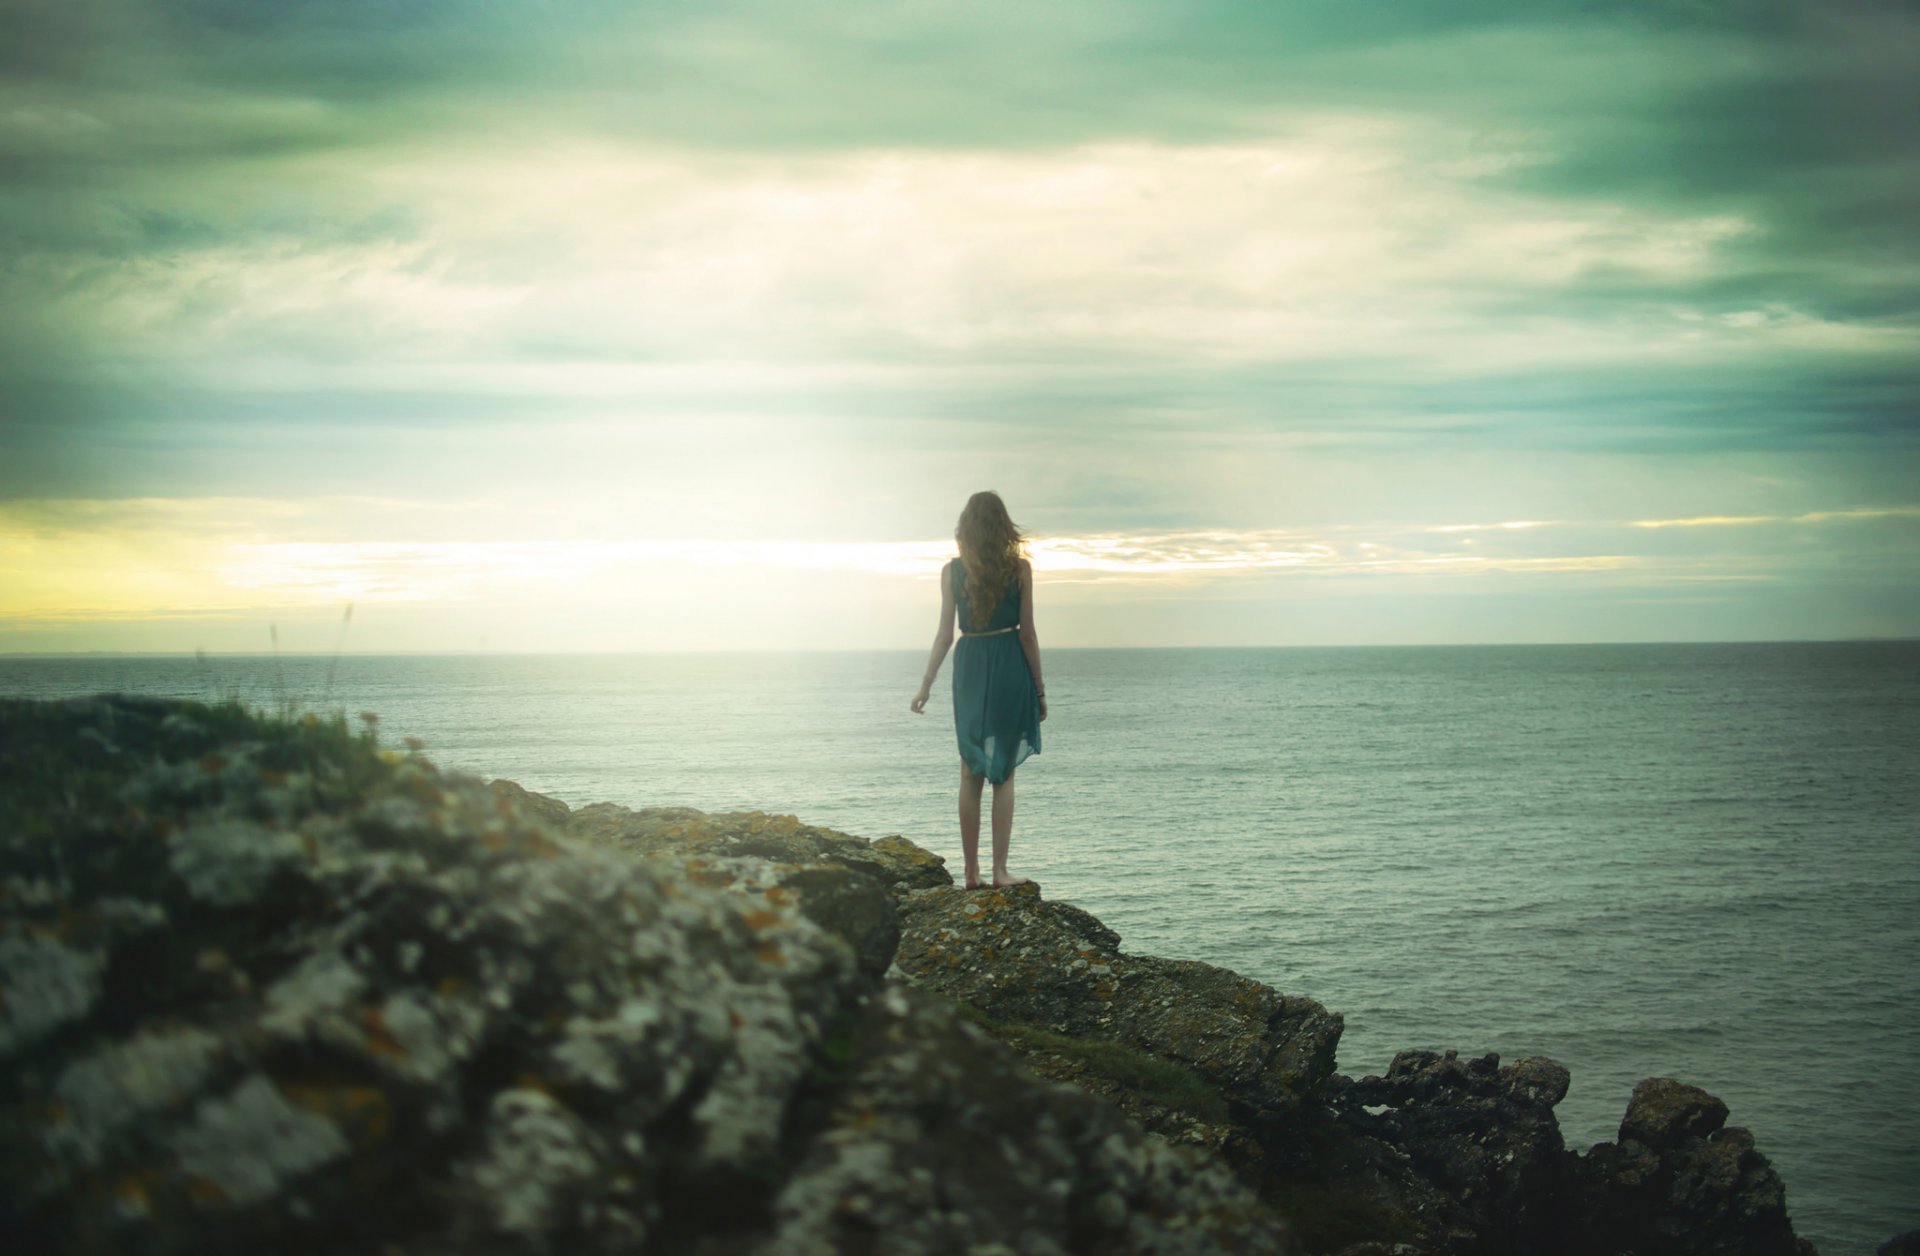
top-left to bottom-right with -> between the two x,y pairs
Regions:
947,559 -> 1041,785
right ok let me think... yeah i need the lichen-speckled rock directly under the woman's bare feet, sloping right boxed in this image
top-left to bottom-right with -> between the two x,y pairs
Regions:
895,883 -> 1340,1125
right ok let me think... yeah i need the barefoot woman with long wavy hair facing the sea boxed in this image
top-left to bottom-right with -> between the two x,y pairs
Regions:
914,492 -> 1046,889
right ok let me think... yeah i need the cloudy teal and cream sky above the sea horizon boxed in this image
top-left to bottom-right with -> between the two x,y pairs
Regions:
0,0 -> 1920,653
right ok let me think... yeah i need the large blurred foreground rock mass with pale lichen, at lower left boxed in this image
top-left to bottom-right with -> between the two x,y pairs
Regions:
0,699 -> 1290,1256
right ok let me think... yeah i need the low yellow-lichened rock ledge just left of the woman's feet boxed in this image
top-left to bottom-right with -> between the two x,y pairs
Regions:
566,803 -> 952,895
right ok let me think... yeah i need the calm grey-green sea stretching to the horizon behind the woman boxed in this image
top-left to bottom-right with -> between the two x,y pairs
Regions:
0,641 -> 1920,1256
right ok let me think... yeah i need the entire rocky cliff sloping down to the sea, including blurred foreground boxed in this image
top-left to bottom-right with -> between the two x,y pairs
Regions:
0,699 -> 1809,1256
